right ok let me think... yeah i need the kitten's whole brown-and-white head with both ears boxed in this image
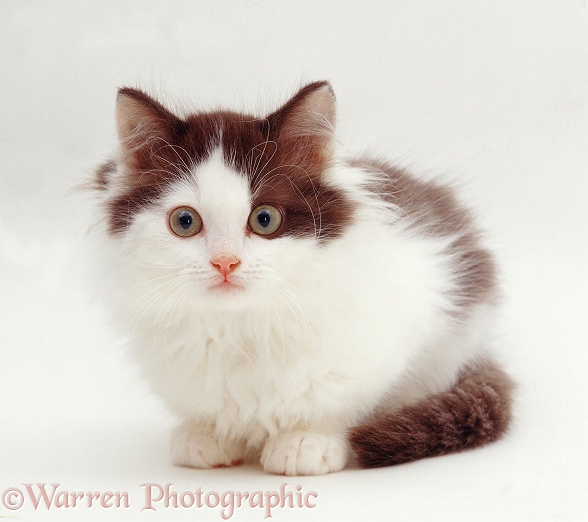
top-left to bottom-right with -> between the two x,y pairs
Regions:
96,82 -> 353,308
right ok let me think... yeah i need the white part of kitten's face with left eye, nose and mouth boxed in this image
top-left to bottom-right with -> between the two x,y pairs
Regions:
123,150 -> 317,308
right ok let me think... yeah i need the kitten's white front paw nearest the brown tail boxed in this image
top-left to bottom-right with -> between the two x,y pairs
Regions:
261,431 -> 348,475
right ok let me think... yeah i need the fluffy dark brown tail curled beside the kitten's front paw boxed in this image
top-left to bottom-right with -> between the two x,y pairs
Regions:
349,361 -> 514,467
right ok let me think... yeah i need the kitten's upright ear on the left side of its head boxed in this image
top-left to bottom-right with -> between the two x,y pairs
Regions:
116,87 -> 181,160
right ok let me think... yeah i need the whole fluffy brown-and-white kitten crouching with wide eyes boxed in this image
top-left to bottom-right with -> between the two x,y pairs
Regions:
89,82 -> 513,475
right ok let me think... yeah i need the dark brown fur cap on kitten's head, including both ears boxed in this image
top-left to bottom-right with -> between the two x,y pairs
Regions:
96,82 -> 353,241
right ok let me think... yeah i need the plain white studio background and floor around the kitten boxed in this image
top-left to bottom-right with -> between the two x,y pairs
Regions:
0,0 -> 588,521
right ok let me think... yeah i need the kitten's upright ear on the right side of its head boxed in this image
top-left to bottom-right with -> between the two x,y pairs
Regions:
268,81 -> 335,149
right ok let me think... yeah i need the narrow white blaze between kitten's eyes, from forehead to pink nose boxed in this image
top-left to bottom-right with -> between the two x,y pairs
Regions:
193,149 -> 251,254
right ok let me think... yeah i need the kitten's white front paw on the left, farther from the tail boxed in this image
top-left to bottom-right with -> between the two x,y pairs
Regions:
171,424 -> 245,468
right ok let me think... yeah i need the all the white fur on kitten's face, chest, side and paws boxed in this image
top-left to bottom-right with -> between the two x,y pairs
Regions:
92,147 -> 496,474
